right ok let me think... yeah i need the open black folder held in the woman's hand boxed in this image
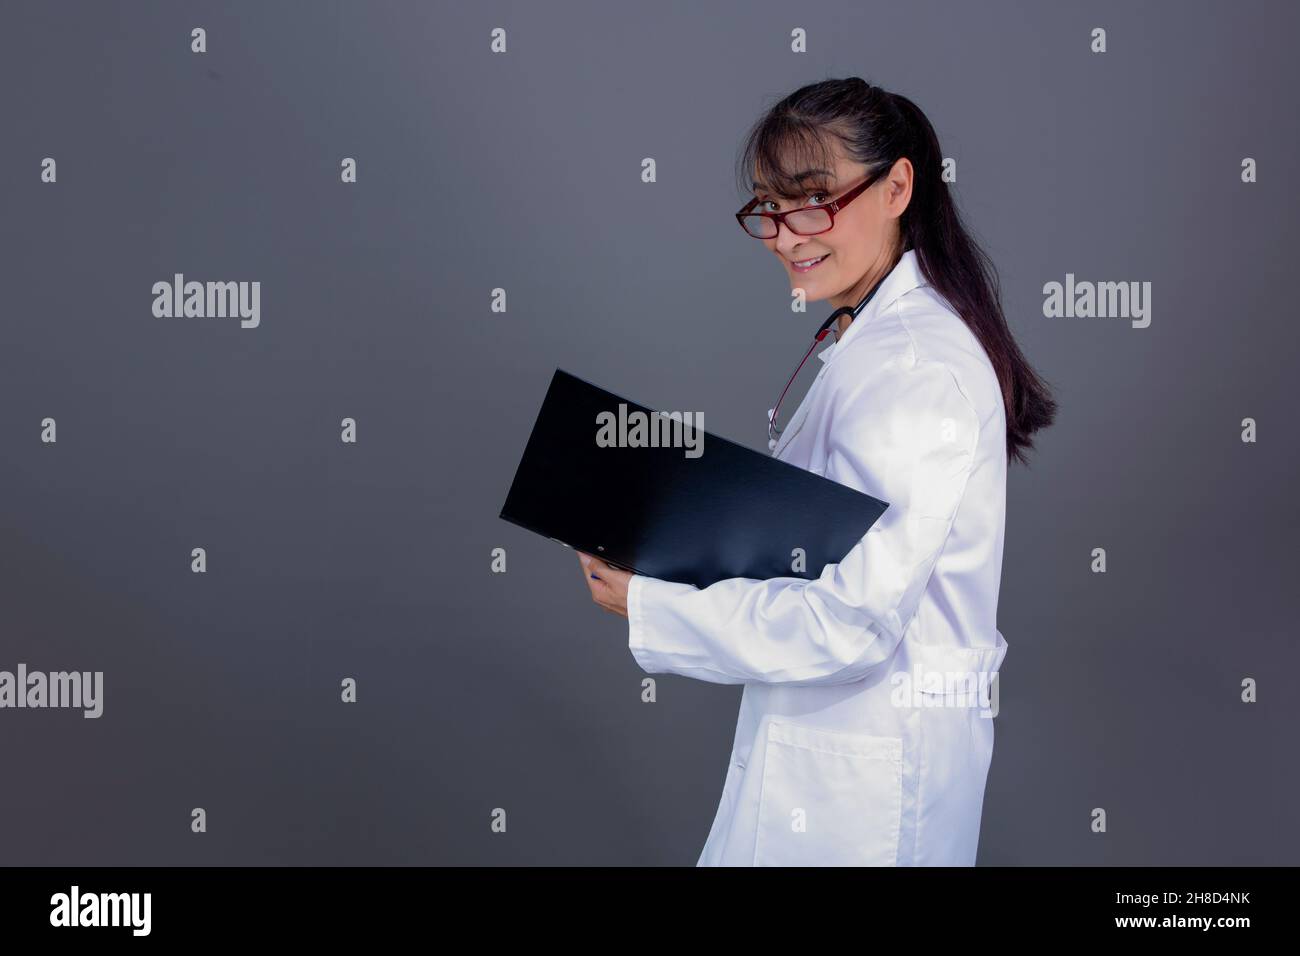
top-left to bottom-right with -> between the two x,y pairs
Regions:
501,368 -> 889,588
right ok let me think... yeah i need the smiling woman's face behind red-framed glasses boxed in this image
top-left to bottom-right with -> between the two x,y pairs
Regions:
754,142 -> 911,307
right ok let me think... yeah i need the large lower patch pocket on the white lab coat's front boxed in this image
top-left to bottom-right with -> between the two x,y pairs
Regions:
754,721 -> 902,866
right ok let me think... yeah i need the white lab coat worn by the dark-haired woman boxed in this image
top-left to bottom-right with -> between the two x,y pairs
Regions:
628,250 -> 1008,866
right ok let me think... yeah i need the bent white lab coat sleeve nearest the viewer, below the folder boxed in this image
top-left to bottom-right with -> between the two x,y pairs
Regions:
628,360 -> 979,685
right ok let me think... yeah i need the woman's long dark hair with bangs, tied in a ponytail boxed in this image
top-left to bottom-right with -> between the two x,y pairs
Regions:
737,77 -> 1057,464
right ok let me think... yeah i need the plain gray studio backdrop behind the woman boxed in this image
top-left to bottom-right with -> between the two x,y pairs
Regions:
0,1 -> 1300,865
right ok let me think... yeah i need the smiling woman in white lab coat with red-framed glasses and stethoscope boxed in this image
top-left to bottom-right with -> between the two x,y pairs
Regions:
579,78 -> 1056,866
